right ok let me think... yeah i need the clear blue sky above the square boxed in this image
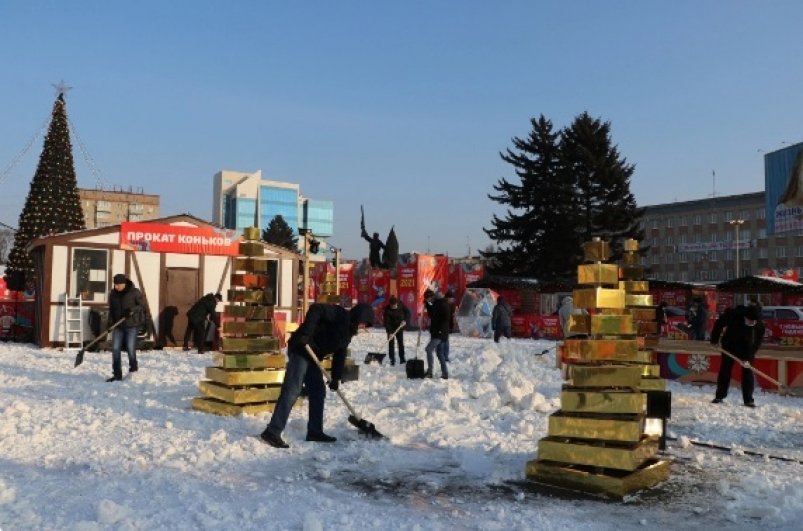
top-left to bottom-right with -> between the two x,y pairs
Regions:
0,0 -> 803,258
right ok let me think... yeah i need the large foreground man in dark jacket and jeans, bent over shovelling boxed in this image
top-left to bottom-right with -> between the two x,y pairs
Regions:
260,303 -> 374,448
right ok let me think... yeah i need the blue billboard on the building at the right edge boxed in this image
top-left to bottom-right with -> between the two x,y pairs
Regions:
764,142 -> 803,235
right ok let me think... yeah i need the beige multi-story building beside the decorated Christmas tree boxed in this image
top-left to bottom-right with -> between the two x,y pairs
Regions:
78,188 -> 160,229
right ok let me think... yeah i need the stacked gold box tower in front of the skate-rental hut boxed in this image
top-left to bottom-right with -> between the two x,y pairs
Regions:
192,227 -> 286,415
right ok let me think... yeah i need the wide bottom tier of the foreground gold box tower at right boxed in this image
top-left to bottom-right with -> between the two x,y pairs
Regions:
526,459 -> 670,498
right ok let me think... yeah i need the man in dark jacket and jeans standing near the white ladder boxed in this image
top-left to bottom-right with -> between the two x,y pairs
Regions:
106,274 -> 148,382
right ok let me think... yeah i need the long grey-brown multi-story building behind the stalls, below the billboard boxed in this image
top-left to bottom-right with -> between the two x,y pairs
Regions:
642,192 -> 803,282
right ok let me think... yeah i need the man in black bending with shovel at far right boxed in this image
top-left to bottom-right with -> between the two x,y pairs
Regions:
711,306 -> 764,407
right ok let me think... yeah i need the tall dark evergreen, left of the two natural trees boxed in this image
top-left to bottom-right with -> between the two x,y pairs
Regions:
481,115 -> 579,279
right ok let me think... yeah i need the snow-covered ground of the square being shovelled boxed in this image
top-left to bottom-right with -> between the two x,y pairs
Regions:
0,331 -> 803,531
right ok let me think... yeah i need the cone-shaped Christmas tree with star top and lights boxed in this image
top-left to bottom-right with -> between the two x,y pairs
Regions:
6,90 -> 86,286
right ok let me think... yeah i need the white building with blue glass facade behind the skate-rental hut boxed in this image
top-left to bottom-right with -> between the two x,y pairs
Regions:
212,170 -> 334,245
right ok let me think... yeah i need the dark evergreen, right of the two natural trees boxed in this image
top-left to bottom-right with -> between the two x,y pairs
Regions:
560,112 -> 644,259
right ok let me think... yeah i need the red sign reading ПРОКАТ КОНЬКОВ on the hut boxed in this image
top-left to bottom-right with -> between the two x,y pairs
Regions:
120,222 -> 240,256
